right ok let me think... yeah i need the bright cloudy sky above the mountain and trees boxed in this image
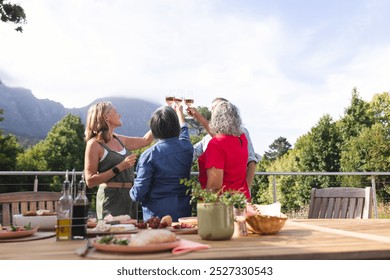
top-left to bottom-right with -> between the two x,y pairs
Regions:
0,0 -> 390,154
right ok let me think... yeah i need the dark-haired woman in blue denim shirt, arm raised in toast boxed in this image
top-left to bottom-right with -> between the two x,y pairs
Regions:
130,105 -> 193,221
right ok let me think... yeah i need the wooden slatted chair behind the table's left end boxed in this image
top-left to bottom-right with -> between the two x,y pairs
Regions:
0,191 -> 61,226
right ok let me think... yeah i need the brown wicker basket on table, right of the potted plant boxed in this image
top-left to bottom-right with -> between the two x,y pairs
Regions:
246,214 -> 287,234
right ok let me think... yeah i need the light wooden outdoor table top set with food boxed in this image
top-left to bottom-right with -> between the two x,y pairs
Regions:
0,219 -> 390,260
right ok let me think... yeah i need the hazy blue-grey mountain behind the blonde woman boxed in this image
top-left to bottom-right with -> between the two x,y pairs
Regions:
0,81 -> 160,144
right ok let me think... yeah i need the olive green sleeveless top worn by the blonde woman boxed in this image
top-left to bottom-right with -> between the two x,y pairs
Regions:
98,136 -> 134,183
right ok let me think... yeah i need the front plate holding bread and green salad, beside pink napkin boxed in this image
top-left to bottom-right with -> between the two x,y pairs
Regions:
91,229 -> 180,253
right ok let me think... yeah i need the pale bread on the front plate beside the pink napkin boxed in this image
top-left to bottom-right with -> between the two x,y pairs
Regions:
129,229 -> 176,246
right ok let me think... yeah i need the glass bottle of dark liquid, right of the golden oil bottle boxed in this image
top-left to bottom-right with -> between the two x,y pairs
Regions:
72,175 -> 88,239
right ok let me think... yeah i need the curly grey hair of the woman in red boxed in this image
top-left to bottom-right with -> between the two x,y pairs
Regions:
210,101 -> 242,136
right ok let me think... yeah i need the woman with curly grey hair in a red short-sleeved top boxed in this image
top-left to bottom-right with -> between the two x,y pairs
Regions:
198,101 -> 250,201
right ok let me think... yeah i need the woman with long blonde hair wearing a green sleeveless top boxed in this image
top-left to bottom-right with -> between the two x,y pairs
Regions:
84,101 -> 153,219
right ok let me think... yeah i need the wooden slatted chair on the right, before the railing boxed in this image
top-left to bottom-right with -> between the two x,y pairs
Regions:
309,187 -> 373,219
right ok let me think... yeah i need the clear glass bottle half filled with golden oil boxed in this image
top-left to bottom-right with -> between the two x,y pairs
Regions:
56,171 -> 73,240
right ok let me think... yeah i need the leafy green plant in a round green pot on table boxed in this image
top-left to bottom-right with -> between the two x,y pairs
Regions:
181,179 -> 246,240
